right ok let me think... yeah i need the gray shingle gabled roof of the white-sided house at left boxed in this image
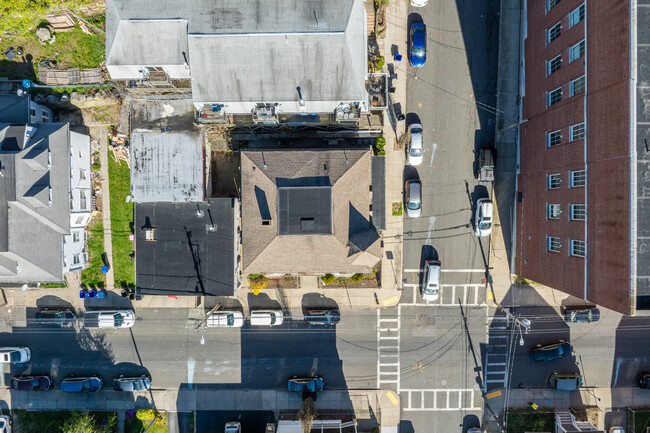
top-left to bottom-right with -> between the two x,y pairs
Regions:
0,123 -> 70,283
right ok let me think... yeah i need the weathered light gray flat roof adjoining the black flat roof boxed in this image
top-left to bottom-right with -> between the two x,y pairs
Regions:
130,132 -> 203,203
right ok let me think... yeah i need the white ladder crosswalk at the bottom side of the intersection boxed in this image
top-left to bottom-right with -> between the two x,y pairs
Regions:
400,389 -> 483,412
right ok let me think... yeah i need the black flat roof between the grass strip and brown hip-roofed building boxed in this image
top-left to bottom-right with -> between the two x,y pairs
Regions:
134,198 -> 239,296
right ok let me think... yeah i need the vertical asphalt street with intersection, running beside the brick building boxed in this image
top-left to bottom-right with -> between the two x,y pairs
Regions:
398,0 -> 502,432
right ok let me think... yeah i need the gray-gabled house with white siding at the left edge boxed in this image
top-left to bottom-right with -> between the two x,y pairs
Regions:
0,123 -> 90,284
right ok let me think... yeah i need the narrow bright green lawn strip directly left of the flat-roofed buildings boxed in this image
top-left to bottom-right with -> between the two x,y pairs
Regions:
108,155 -> 135,287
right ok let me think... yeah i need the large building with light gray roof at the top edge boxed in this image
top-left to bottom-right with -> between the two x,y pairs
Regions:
106,0 -> 368,118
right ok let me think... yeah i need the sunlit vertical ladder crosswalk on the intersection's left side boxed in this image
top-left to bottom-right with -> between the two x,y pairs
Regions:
377,307 -> 401,393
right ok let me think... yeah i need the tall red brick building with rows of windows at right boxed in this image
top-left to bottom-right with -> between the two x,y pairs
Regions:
515,0 -> 650,314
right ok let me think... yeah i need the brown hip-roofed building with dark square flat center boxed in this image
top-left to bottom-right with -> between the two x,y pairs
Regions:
241,149 -> 382,275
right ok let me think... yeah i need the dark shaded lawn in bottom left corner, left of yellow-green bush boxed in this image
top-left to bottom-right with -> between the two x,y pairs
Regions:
13,409 -> 117,433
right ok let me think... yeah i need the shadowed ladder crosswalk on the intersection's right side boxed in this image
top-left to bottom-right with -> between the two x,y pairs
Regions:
483,316 -> 510,392
